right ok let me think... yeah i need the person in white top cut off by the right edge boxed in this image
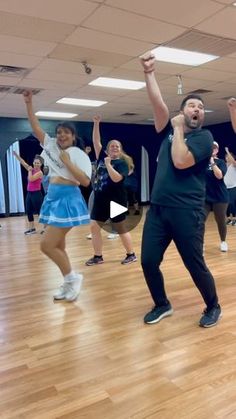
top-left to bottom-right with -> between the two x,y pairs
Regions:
224,147 -> 236,226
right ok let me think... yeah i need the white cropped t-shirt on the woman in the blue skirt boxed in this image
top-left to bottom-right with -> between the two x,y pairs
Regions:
41,134 -> 92,184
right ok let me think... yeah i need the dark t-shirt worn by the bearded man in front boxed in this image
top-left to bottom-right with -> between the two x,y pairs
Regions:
151,121 -> 213,208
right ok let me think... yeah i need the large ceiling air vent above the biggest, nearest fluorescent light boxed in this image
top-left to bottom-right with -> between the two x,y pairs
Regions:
165,30 -> 236,56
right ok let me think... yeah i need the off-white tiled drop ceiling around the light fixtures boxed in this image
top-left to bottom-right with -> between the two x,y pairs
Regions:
0,0 -> 236,124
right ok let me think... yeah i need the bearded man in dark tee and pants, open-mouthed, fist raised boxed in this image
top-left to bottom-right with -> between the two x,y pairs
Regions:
141,52 -> 221,327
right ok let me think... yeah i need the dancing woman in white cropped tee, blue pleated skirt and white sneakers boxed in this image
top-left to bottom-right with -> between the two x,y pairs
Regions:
24,91 -> 91,301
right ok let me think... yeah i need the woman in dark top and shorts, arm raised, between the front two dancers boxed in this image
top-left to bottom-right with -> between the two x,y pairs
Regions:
86,116 -> 137,266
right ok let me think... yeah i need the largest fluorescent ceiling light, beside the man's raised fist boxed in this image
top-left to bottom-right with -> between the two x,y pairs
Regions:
152,47 -> 219,66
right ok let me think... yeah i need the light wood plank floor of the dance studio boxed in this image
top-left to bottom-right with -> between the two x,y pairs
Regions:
0,213 -> 236,419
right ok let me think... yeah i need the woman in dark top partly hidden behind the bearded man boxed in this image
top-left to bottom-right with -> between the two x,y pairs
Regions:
205,141 -> 229,252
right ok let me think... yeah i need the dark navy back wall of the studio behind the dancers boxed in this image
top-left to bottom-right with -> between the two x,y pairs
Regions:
0,118 -> 236,217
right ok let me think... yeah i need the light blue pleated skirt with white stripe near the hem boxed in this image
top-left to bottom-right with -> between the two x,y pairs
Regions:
39,183 -> 90,228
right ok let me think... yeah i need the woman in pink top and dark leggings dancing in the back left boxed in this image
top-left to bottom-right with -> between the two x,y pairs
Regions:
13,151 -> 43,236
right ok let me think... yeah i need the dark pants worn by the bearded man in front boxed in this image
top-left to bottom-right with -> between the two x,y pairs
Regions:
141,204 -> 218,308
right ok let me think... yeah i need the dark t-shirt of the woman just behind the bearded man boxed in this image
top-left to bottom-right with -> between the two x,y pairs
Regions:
206,159 -> 229,203
